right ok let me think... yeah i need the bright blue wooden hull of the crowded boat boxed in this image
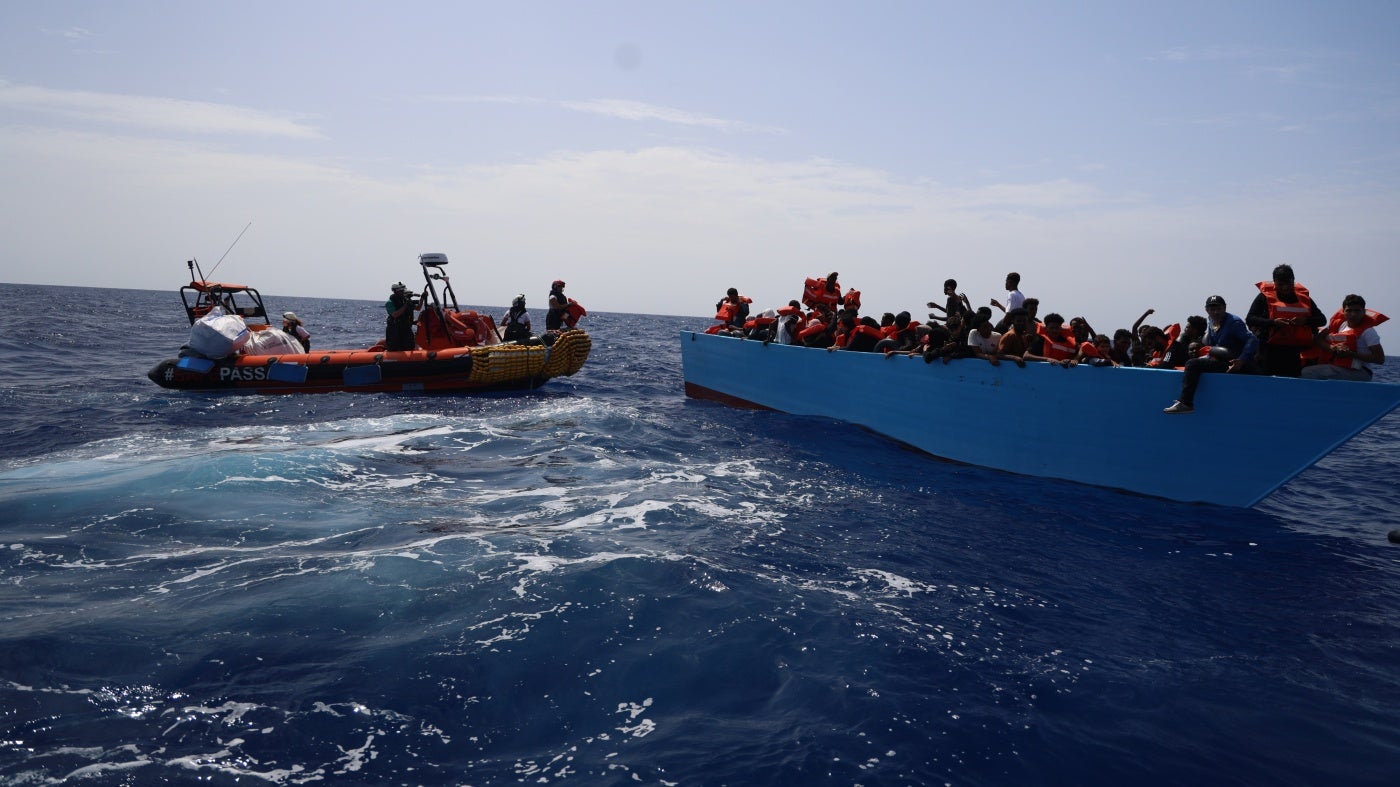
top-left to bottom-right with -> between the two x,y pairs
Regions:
680,330 -> 1400,507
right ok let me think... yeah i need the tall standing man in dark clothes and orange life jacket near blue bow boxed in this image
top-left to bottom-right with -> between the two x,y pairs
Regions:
1245,265 -> 1327,377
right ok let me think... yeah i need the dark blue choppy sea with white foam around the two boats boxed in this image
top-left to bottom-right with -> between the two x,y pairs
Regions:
0,284 -> 1400,787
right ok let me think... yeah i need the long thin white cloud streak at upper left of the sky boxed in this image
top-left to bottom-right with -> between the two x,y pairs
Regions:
0,81 -> 322,139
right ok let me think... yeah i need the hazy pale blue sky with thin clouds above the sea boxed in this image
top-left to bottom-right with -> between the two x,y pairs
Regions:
0,0 -> 1400,330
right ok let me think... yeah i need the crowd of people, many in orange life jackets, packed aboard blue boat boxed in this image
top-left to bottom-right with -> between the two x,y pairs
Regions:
708,265 -> 1386,415
